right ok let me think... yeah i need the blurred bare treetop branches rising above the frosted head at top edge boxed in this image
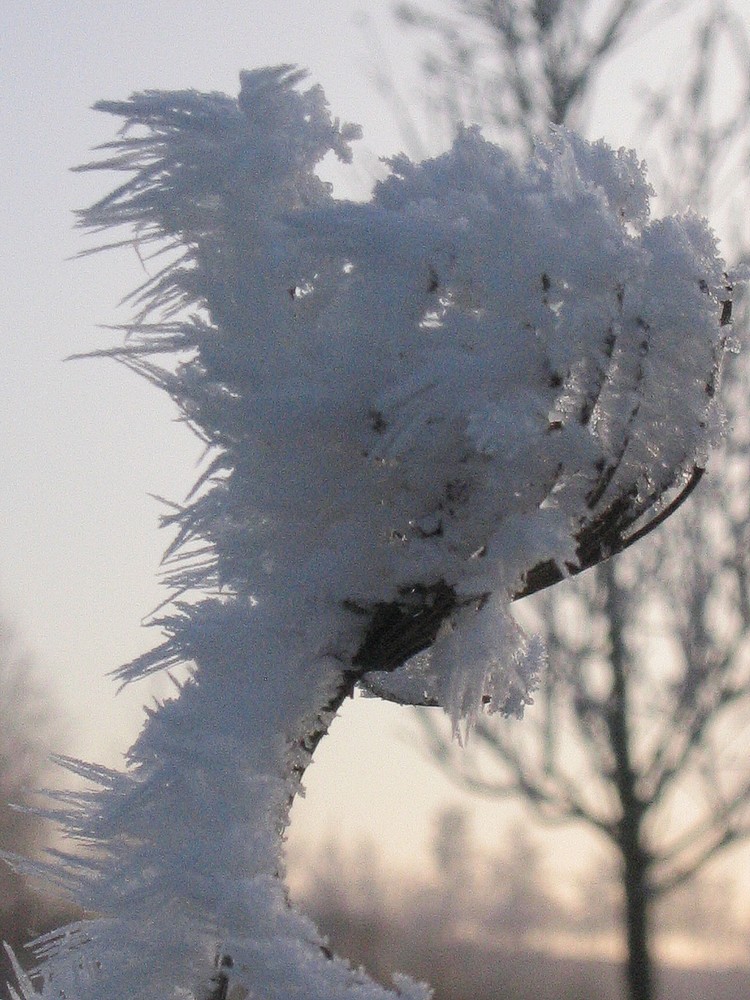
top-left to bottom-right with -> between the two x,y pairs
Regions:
396,0 -> 695,148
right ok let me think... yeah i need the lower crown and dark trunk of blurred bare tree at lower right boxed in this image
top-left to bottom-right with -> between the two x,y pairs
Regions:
426,524 -> 750,1000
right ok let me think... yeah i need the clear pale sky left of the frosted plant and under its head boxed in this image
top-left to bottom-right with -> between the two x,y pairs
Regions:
0,0 -> 748,888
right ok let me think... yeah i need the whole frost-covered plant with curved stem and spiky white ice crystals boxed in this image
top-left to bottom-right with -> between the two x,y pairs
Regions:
8,68 -> 728,1000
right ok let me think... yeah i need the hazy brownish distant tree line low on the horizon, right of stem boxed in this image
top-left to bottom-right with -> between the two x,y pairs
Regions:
290,808 -> 750,1000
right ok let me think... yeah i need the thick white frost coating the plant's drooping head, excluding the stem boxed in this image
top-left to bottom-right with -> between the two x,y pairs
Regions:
83,68 -> 726,721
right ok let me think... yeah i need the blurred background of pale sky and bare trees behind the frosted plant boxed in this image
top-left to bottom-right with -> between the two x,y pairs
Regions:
0,0 -> 750,1000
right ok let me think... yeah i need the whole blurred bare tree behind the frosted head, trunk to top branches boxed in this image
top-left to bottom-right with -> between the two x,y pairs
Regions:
400,0 -> 750,1000
